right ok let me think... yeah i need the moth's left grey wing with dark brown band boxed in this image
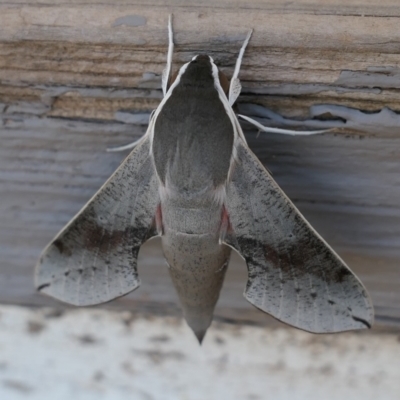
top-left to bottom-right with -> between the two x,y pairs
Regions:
35,140 -> 159,306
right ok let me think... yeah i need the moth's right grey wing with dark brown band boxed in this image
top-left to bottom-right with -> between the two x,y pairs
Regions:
225,139 -> 373,333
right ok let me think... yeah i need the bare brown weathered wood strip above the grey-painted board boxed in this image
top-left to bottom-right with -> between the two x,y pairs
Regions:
0,0 -> 400,120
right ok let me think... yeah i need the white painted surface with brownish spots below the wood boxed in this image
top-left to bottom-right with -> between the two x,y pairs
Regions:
0,306 -> 400,400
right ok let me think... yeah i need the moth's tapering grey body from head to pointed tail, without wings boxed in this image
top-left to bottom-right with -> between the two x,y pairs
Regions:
152,56 -> 234,340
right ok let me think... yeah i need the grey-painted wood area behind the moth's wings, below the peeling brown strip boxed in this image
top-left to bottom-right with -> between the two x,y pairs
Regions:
0,118 -> 400,330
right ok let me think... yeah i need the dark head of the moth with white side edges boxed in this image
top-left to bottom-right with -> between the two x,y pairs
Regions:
168,54 -> 229,95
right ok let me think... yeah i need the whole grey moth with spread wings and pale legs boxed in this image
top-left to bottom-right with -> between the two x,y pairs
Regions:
35,17 -> 373,343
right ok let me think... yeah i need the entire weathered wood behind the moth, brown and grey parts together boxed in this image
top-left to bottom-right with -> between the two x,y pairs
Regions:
0,0 -> 400,325
